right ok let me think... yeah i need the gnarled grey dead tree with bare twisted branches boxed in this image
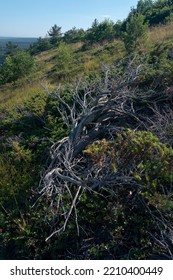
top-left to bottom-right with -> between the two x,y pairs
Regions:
40,58 -> 173,253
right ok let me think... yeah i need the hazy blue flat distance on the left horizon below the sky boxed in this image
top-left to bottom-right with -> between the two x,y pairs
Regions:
0,37 -> 38,63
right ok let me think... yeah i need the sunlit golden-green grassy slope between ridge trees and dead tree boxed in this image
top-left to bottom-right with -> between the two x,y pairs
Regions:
0,41 -> 124,109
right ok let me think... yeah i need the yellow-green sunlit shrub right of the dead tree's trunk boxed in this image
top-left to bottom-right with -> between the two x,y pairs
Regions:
85,130 -> 173,209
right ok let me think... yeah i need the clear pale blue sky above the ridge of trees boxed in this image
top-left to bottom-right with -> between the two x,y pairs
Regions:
0,0 -> 138,37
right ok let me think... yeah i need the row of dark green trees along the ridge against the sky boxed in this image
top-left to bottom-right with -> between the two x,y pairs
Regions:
32,0 -> 173,53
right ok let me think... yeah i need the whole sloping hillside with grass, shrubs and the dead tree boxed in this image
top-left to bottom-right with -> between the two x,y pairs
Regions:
0,1 -> 173,260
